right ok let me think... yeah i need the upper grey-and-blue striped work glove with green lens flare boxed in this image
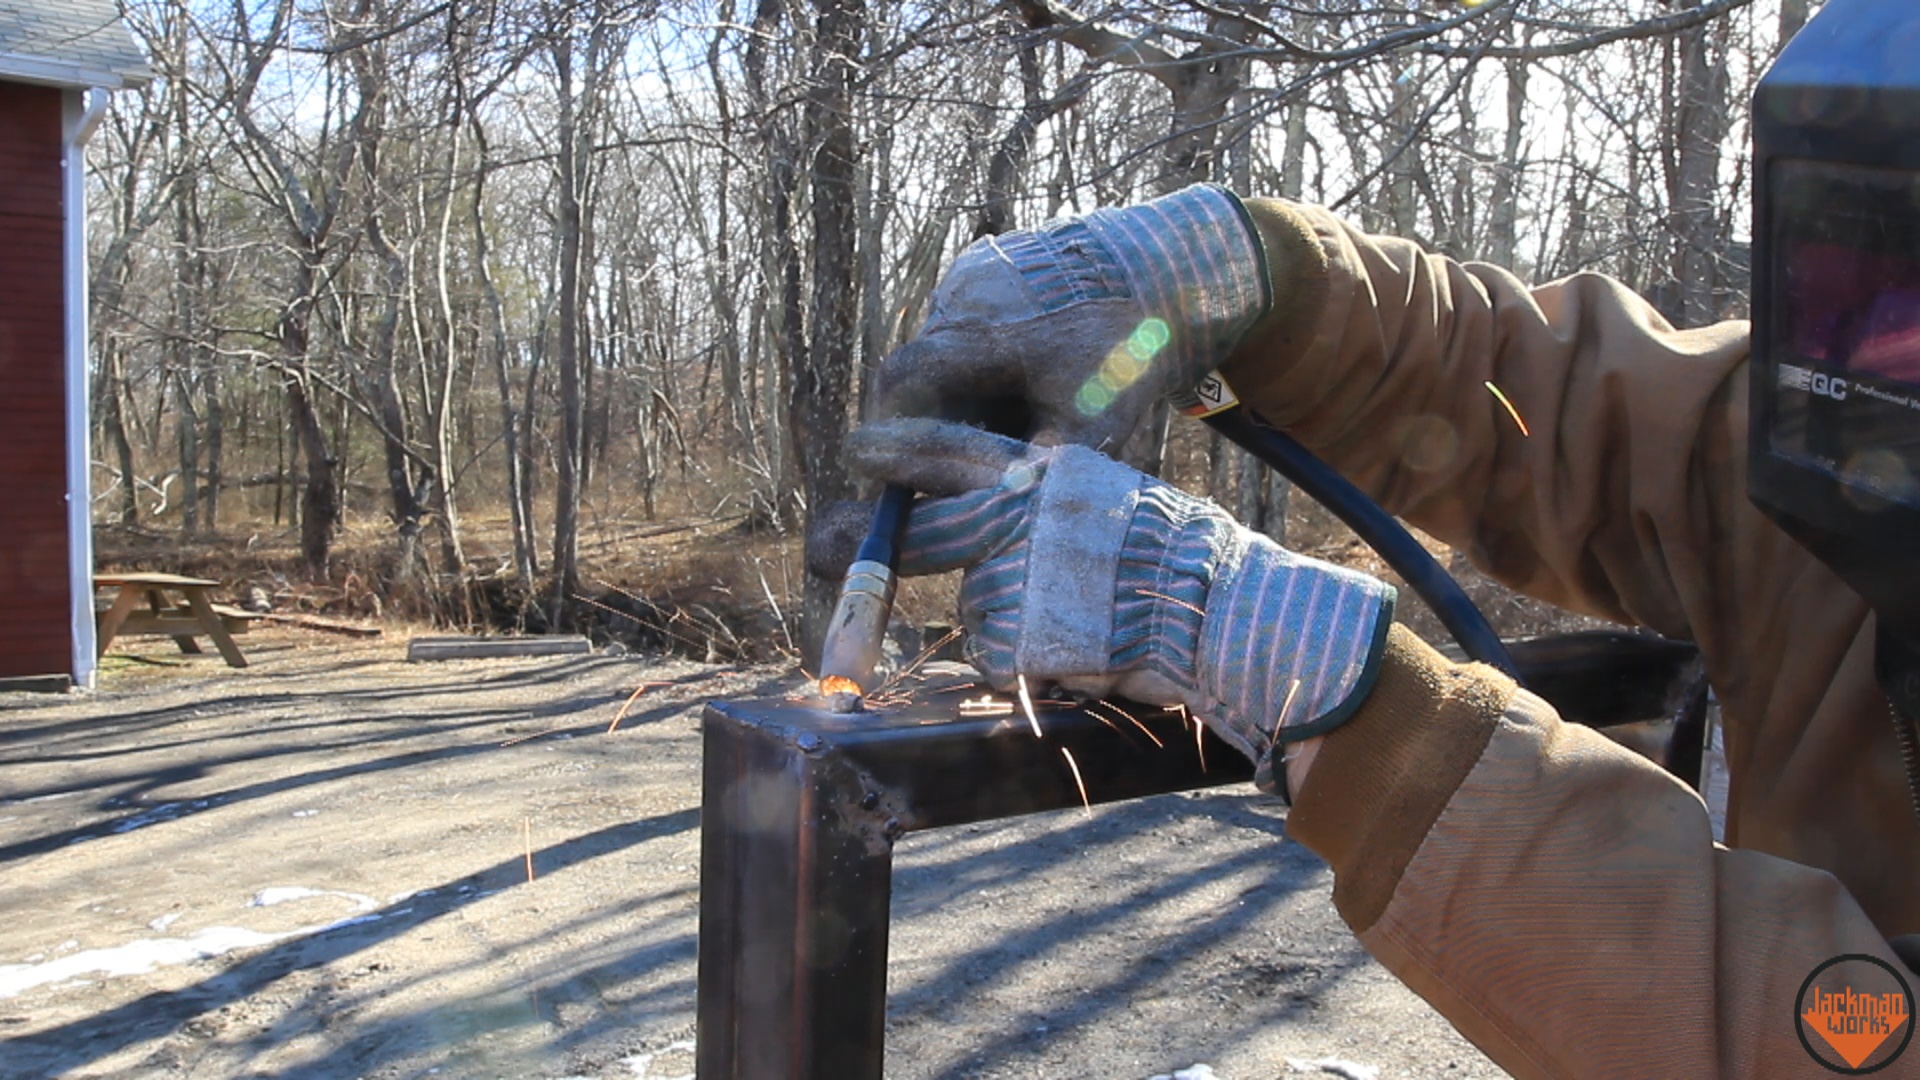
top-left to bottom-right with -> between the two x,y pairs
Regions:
876,184 -> 1273,454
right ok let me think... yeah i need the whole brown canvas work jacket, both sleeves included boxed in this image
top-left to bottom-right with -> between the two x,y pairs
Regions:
1223,200 -> 1920,1076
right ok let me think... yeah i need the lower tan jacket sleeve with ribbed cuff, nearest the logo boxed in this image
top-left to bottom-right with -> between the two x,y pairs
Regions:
1288,626 -> 1914,1078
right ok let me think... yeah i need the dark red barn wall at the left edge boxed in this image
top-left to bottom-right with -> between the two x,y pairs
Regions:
0,83 -> 73,676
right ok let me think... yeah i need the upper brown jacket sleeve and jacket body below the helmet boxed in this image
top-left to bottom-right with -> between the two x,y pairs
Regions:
1223,200 -> 1896,922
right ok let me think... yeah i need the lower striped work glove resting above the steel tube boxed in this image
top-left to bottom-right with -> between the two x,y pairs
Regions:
851,419 -> 1394,790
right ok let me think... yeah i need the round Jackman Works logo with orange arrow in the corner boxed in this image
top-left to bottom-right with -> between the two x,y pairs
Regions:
1793,953 -> 1914,1076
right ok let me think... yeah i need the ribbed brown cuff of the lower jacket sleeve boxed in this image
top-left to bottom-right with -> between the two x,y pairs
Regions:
1286,626 -> 1515,932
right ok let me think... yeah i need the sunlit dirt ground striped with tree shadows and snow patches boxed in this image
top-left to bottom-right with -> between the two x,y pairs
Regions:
0,630 -> 1500,1080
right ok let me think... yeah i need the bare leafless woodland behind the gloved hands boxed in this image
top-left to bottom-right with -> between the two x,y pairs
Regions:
88,0 -> 1818,651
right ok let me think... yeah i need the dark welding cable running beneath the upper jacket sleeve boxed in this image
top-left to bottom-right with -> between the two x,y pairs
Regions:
1206,405 -> 1521,678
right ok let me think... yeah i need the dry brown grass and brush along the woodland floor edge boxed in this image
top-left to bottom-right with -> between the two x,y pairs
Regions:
94,476 -> 1596,661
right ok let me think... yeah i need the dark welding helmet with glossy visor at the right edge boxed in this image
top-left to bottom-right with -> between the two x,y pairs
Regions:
1747,0 -> 1920,717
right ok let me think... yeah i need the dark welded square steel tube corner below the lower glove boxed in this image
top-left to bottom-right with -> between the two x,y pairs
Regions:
695,694 -> 1252,1080
